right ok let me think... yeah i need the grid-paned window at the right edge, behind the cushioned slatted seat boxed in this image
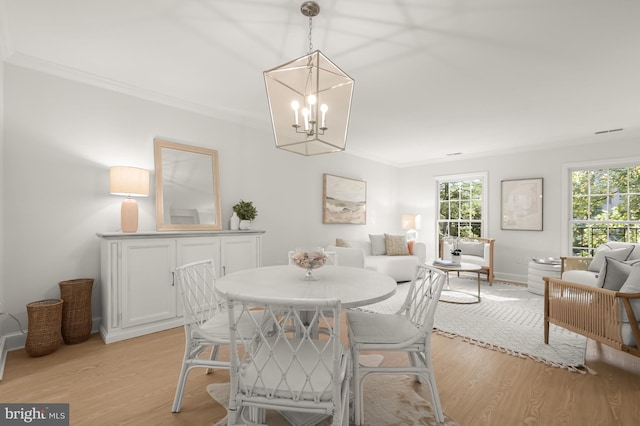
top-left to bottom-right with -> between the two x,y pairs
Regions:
571,166 -> 640,256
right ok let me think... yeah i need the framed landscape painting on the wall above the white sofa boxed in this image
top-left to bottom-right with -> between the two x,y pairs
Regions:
322,173 -> 367,225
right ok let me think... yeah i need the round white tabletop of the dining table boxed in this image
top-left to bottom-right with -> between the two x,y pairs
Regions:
215,265 -> 397,308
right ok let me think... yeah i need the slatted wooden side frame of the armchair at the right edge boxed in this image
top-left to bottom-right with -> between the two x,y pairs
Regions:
544,277 -> 640,357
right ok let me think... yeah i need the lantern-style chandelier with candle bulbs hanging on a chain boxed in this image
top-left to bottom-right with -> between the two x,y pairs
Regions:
263,1 -> 354,155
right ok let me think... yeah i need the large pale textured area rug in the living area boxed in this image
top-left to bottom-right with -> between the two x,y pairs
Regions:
361,276 -> 593,373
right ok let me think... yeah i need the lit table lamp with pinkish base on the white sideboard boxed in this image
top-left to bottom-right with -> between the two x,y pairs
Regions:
109,166 -> 149,232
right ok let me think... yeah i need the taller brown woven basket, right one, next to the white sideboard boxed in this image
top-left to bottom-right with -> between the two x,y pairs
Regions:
58,278 -> 93,345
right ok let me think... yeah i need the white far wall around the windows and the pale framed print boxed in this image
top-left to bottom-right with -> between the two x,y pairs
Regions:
398,135 -> 640,282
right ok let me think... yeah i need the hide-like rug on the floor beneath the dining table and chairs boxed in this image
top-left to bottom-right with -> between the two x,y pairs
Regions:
207,374 -> 458,426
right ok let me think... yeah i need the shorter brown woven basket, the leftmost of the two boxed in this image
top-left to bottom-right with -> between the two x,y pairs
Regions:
24,299 -> 62,357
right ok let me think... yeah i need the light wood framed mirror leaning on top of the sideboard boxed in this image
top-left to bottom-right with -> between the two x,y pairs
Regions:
153,139 -> 222,231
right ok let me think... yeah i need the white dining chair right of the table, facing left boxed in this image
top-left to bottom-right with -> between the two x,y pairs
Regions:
347,265 -> 445,425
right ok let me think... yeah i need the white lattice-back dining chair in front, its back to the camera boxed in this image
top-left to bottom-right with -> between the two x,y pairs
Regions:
227,294 -> 352,425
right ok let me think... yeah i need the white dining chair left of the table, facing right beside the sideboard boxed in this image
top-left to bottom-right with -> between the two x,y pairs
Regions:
171,259 -> 253,413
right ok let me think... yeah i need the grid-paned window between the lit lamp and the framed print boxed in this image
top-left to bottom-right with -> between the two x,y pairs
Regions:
438,175 -> 486,237
